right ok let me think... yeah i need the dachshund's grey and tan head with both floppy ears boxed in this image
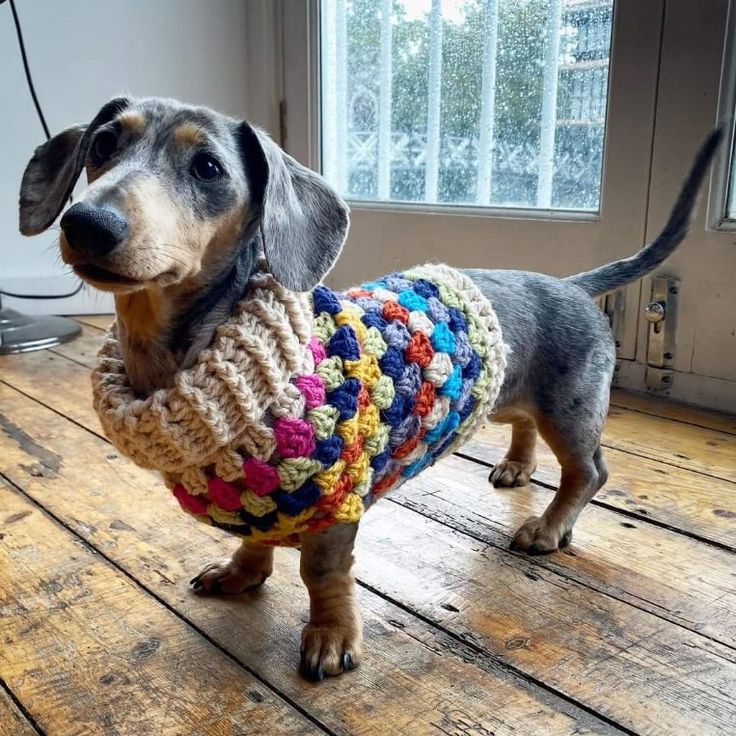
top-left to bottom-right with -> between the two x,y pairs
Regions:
20,98 -> 348,293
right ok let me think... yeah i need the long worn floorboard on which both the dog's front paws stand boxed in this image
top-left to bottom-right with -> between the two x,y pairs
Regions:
0,386 -> 615,734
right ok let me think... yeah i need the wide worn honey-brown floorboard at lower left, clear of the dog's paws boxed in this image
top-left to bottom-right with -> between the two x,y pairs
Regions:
0,481 -> 319,736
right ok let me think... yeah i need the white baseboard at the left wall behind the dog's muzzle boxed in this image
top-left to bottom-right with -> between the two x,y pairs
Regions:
0,276 -> 115,315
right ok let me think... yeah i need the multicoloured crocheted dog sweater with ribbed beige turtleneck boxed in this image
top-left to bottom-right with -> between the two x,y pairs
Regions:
92,264 -> 506,545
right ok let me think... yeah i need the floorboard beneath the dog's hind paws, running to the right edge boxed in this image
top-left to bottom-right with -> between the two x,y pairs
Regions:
390,457 -> 736,647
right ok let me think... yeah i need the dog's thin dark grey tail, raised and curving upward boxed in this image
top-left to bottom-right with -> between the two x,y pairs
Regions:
566,127 -> 723,296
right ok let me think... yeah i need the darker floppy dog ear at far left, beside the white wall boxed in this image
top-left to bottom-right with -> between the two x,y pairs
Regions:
20,97 -> 130,235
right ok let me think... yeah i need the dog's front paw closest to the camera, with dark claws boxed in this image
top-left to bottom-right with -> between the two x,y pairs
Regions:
300,624 -> 361,681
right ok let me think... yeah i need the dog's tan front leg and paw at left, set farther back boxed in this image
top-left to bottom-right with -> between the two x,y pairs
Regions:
191,541 -> 273,595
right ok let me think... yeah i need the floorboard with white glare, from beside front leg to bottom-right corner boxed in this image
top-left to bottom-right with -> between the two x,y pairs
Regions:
357,503 -> 736,734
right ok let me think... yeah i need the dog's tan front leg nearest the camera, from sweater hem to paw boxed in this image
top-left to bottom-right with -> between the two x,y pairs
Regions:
301,524 -> 363,680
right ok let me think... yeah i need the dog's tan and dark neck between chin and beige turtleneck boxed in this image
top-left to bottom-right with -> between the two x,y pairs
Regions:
115,240 -> 259,396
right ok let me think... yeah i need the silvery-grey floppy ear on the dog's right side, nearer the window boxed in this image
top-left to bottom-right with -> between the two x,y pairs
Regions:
238,123 -> 348,291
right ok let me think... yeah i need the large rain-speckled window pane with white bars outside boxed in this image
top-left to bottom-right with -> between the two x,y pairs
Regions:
321,0 -> 613,211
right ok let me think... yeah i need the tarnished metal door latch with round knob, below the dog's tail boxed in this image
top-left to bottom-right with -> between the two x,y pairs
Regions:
644,276 -> 680,391
